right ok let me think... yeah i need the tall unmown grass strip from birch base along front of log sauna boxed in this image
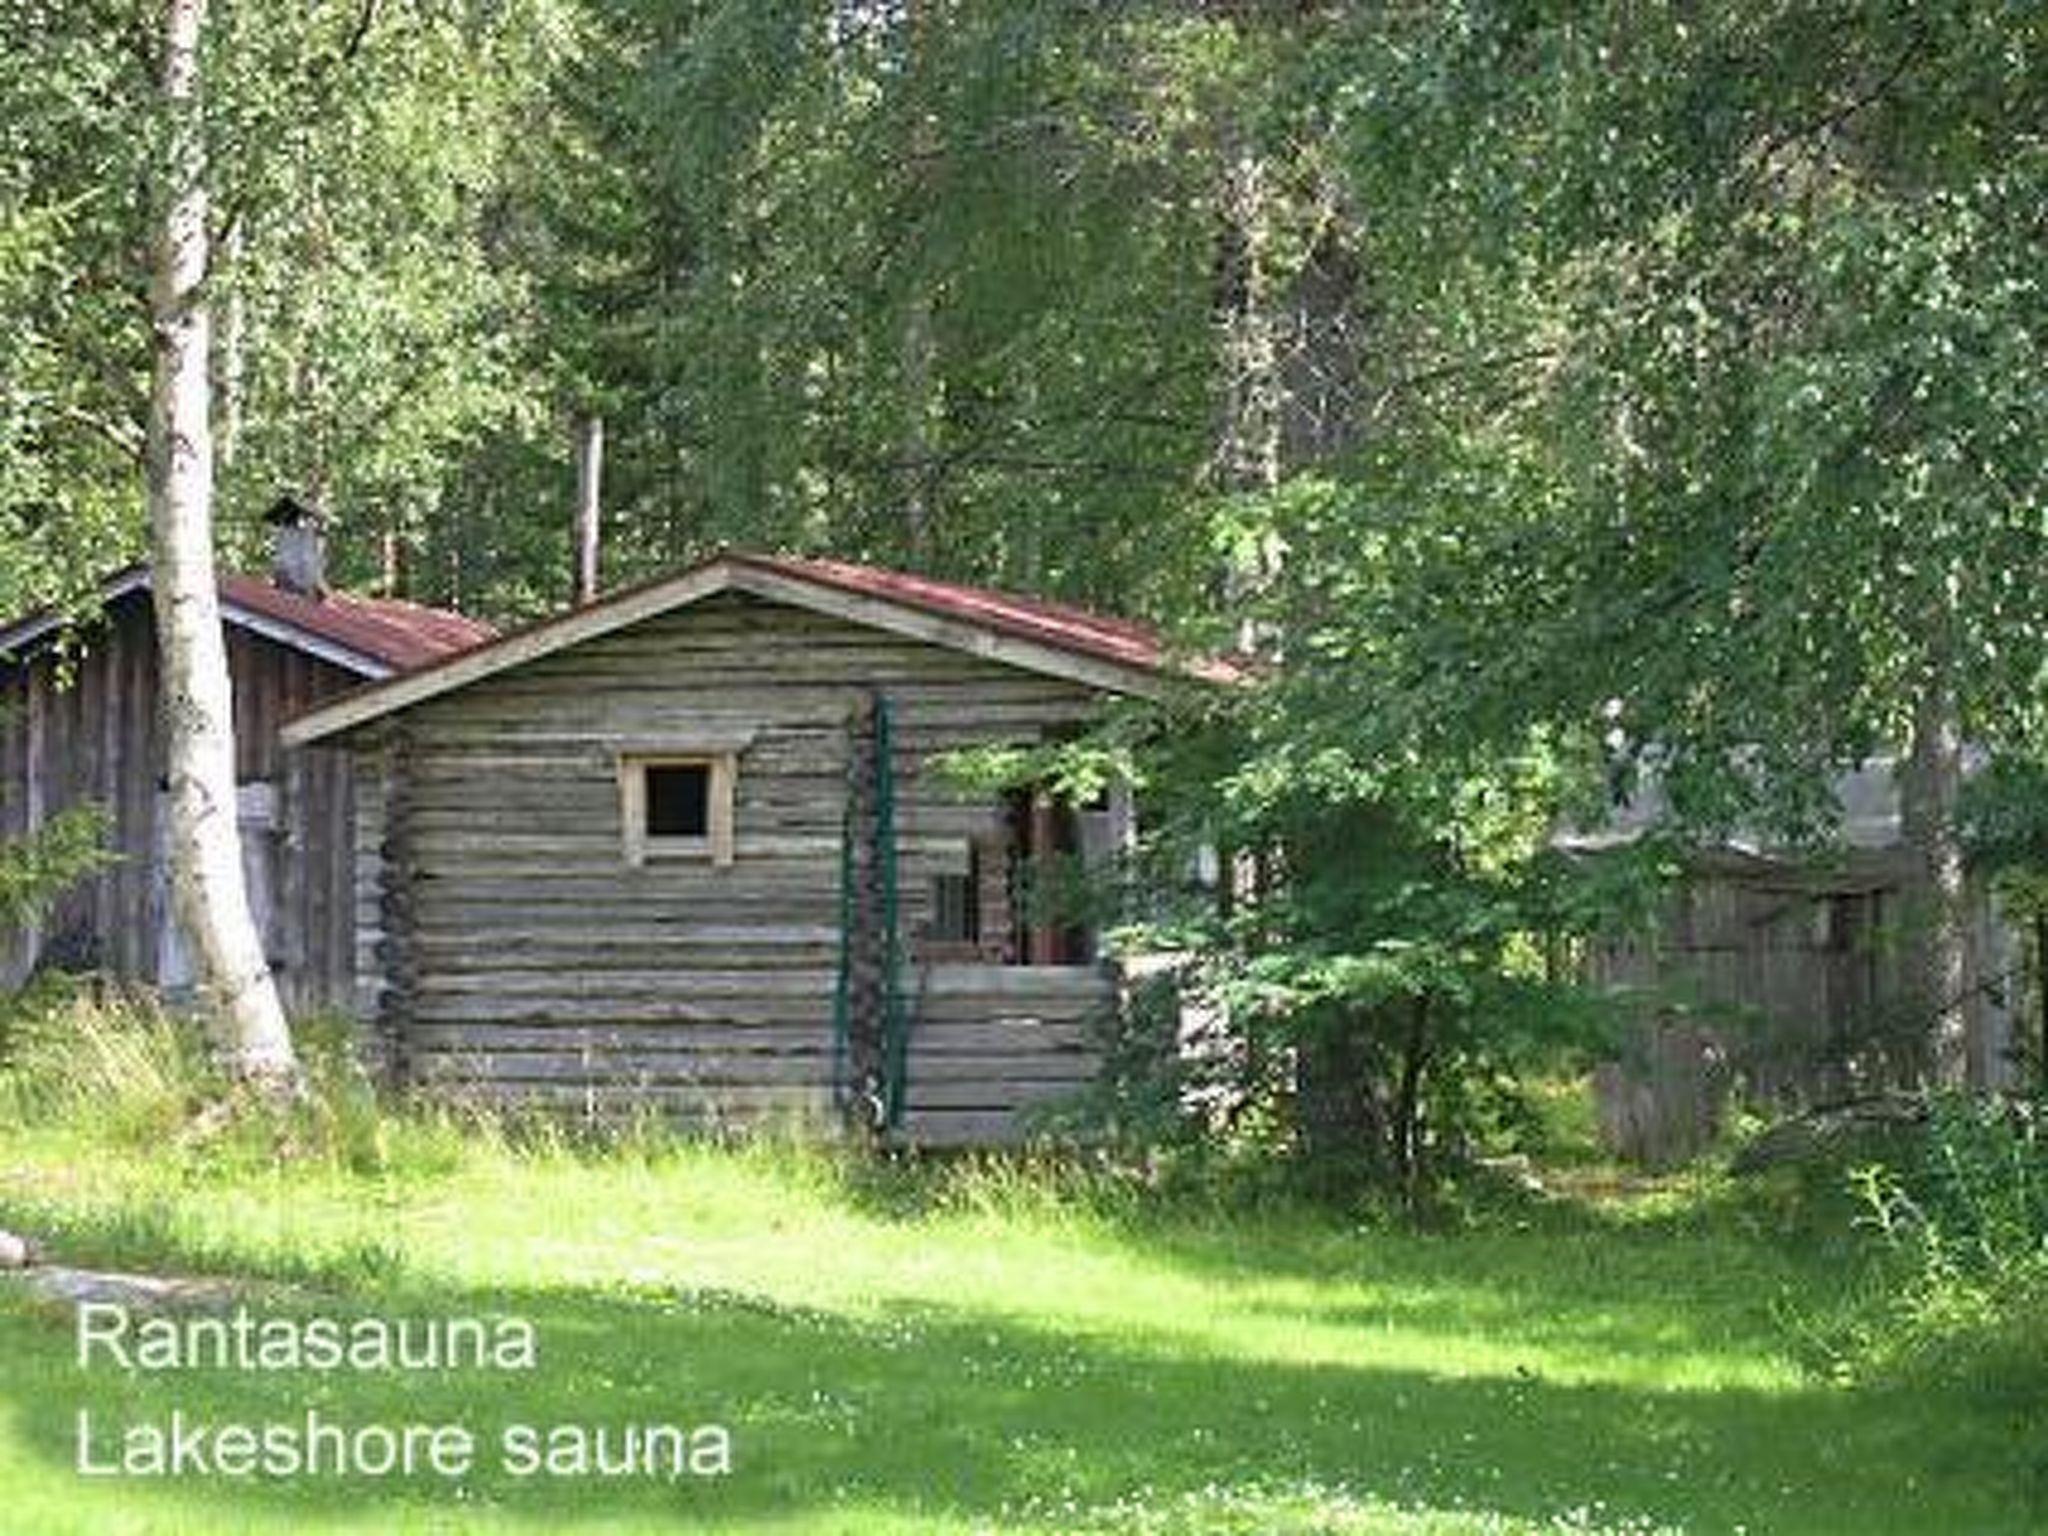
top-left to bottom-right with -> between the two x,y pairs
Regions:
0,991 -> 1145,1223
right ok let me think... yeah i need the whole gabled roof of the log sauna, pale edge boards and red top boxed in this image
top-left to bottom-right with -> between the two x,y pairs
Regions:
285,555 -> 1239,745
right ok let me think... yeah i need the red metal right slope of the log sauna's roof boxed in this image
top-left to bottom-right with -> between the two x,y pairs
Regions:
727,553 -> 1243,682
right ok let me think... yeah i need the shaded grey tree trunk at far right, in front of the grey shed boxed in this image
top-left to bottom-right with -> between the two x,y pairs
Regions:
1898,655 -> 1985,1087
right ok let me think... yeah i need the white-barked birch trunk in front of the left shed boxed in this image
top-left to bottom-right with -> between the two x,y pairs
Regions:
147,0 -> 297,1081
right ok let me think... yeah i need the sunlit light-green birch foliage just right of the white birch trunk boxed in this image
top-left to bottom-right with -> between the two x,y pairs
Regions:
213,0 -> 573,610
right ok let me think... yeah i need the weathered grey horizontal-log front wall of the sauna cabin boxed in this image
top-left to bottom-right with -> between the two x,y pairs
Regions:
356,594 -> 1114,1143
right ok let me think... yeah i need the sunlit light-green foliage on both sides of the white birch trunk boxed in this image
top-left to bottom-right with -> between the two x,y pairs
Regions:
0,0 -> 569,612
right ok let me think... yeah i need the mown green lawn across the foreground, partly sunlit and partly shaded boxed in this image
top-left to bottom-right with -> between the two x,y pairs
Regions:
0,1130 -> 2048,1536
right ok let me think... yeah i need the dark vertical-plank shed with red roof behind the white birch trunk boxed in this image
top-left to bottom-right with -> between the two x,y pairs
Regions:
0,565 -> 494,1012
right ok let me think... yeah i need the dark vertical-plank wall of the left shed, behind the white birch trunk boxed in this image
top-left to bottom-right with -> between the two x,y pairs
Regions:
0,594 -> 358,1012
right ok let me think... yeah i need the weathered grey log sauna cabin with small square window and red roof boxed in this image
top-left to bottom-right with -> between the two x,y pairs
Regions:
285,555 -> 1219,1143
